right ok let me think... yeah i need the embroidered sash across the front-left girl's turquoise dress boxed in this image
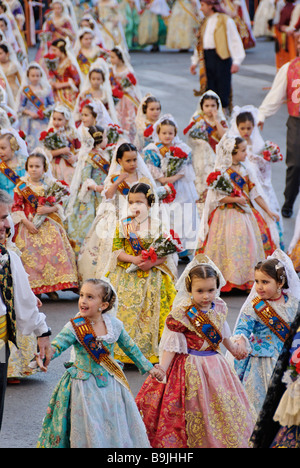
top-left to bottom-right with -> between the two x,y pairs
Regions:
71,317 -> 131,391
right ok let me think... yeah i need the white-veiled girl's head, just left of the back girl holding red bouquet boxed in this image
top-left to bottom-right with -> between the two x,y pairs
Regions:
74,58 -> 119,125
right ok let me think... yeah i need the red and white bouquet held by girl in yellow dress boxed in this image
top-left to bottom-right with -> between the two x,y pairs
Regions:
126,229 -> 183,273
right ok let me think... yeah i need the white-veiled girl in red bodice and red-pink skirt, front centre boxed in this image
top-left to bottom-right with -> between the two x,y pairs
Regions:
136,255 -> 256,448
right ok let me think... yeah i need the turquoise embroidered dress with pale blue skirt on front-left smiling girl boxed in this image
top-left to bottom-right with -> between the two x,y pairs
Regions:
37,314 -> 152,448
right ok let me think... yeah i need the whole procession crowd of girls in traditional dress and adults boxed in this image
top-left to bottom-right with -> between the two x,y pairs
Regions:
0,0 -> 300,448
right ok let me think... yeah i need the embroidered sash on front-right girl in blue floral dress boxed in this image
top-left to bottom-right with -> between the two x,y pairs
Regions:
252,297 -> 290,342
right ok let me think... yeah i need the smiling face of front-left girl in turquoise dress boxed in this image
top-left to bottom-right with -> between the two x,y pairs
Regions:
78,283 -> 107,319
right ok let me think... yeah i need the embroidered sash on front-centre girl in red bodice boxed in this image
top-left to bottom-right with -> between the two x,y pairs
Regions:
185,305 -> 222,351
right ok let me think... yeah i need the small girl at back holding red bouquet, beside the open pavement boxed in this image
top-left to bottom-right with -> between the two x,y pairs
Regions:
110,47 -> 141,143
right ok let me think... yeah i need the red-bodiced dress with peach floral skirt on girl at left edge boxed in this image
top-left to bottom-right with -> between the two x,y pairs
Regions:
12,176 -> 78,294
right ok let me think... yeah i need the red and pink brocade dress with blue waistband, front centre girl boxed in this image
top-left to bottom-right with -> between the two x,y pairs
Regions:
136,298 -> 255,448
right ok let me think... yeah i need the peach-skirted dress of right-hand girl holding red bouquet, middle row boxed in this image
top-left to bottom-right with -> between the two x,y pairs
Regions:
199,165 -> 276,291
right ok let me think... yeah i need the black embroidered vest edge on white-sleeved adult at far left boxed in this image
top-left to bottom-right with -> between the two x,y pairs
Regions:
0,244 -> 17,346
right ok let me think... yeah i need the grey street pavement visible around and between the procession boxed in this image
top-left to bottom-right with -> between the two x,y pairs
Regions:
0,39 -> 299,448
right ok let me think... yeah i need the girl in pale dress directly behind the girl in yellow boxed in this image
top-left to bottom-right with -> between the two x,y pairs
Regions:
78,138 -> 159,281
